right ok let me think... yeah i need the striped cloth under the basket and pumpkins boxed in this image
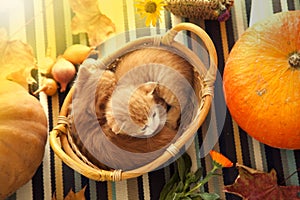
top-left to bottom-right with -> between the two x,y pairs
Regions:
0,0 -> 300,200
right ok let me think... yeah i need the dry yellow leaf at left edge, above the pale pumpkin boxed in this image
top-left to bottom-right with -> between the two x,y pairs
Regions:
0,29 -> 35,89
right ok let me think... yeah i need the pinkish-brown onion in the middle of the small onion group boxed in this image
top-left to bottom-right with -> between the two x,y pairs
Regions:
51,57 -> 76,92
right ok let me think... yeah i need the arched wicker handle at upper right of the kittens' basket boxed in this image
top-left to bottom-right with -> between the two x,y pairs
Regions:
161,22 -> 218,96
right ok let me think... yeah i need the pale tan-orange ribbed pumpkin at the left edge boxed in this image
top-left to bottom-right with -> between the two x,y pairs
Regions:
0,79 -> 47,199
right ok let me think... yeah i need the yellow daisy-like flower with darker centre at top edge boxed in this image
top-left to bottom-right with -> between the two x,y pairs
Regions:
135,0 -> 166,26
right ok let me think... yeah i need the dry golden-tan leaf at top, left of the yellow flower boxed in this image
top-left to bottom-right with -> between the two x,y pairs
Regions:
70,0 -> 116,46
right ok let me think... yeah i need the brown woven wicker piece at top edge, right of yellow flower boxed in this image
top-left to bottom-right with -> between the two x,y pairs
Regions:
165,0 -> 234,21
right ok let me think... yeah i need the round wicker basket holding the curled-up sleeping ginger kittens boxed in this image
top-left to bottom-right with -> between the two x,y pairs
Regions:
50,23 -> 217,181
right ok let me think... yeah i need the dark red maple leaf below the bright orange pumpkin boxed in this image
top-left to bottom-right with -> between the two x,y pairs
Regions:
225,164 -> 300,200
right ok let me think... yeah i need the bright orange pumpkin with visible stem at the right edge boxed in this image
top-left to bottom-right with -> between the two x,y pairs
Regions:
223,10 -> 300,149
